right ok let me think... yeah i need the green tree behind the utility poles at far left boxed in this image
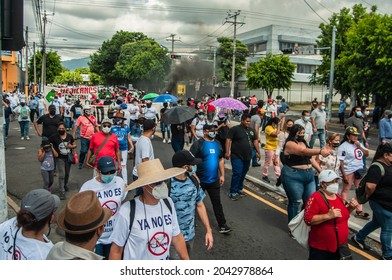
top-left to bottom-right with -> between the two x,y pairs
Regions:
29,51 -> 63,84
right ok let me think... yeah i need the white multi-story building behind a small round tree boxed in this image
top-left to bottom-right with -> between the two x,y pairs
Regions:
237,25 -> 328,103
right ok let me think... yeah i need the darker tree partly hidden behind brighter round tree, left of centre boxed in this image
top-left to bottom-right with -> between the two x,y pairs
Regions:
89,30 -> 148,85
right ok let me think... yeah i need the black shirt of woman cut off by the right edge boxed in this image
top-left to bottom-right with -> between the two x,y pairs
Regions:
366,162 -> 392,211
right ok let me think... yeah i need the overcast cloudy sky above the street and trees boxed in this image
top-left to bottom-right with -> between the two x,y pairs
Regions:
24,0 -> 392,60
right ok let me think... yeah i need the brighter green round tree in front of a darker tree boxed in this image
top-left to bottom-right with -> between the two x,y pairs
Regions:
113,39 -> 170,90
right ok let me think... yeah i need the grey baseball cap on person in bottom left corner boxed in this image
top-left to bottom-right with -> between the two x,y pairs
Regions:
20,189 -> 60,222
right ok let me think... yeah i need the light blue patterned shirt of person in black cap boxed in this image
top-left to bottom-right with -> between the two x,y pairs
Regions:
170,177 -> 206,241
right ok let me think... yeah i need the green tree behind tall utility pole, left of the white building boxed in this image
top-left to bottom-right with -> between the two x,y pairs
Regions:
217,37 -> 250,81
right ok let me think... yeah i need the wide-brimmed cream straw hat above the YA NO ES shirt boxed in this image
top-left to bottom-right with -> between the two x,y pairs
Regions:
125,159 -> 186,191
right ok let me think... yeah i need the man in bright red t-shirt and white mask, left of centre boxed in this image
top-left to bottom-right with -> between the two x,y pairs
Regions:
86,118 -> 121,174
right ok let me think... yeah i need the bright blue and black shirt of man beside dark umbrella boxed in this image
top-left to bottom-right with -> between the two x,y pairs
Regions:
190,138 -> 223,184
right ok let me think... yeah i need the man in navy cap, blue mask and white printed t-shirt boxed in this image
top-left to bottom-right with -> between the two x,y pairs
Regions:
80,156 -> 127,259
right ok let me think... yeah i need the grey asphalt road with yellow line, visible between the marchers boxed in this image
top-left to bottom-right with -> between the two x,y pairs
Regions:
6,122 -> 367,260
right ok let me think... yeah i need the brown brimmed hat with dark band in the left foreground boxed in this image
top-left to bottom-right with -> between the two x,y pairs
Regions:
57,191 -> 112,234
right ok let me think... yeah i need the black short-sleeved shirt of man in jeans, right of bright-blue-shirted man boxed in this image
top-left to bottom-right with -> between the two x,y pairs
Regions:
227,124 -> 257,160
